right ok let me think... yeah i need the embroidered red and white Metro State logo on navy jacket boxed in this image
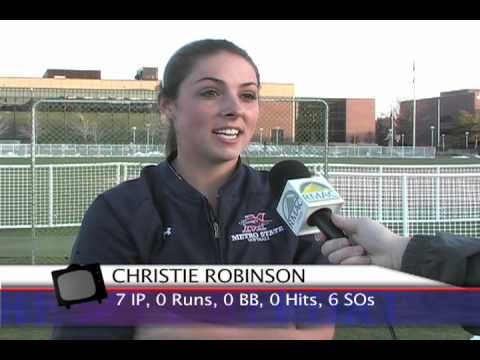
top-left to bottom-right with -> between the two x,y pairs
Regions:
231,212 -> 284,242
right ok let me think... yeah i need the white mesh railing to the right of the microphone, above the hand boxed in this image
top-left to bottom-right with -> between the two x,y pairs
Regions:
329,172 -> 480,236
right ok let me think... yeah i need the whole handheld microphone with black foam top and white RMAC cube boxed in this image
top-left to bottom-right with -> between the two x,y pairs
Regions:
269,160 -> 346,240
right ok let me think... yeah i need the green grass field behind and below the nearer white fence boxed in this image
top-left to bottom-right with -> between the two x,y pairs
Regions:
0,157 -> 480,340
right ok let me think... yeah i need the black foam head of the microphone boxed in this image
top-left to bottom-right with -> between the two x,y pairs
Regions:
269,160 -> 312,200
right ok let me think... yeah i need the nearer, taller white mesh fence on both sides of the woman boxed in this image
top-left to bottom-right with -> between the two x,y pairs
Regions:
0,163 -> 480,236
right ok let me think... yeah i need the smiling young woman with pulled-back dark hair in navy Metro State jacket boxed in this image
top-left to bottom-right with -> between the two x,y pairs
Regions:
53,40 -> 334,339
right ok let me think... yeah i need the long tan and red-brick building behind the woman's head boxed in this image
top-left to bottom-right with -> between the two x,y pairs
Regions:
0,67 -> 375,144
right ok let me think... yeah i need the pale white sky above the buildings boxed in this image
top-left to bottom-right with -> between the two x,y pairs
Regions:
0,20 -> 480,116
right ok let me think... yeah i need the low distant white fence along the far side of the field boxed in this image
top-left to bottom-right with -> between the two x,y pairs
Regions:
0,144 -> 435,158
